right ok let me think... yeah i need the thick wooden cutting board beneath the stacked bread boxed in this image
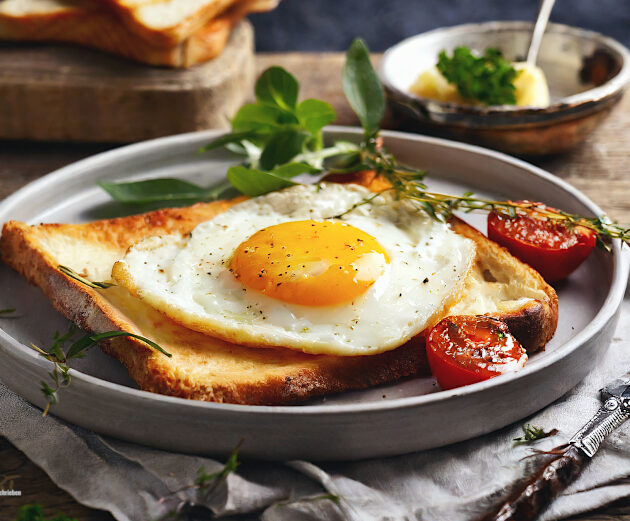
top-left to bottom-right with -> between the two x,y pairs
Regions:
0,21 -> 255,143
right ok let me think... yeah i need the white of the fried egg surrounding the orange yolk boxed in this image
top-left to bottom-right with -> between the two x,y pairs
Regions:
112,183 -> 475,356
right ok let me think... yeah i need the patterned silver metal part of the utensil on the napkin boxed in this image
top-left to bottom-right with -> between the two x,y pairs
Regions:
569,396 -> 630,458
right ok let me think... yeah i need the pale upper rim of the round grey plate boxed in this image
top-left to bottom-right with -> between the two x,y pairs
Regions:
0,126 -> 629,416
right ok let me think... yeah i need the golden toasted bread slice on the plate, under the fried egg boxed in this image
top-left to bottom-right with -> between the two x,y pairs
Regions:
0,190 -> 558,404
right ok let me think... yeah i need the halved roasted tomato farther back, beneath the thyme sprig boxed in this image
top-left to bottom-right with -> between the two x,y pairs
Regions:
488,201 -> 597,282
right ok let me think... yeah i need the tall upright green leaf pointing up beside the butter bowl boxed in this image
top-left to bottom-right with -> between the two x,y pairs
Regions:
341,38 -> 385,136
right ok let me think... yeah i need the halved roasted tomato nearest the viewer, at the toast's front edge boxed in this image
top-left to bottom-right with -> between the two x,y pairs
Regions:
427,315 -> 527,389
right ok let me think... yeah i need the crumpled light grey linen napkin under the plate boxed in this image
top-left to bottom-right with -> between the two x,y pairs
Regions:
0,295 -> 630,521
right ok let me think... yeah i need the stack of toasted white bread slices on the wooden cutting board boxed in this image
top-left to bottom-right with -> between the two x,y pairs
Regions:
0,0 -> 279,67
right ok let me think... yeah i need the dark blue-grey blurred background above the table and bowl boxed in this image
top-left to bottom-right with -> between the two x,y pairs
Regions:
250,0 -> 630,51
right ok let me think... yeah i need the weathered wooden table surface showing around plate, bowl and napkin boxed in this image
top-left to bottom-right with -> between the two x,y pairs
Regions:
0,53 -> 630,521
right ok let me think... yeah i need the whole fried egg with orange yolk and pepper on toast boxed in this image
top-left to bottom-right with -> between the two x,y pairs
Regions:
112,183 -> 475,356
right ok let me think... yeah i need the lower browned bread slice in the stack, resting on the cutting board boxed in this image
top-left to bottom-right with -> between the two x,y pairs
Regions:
0,0 -> 276,67
